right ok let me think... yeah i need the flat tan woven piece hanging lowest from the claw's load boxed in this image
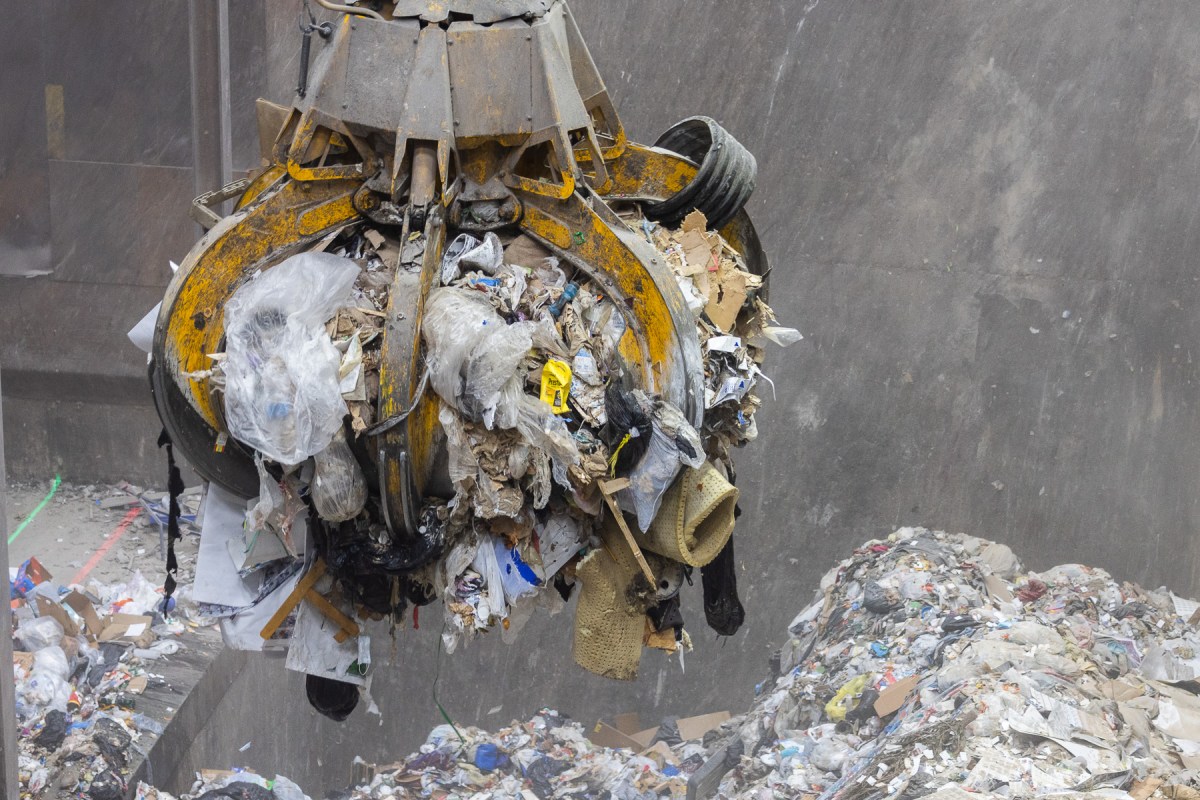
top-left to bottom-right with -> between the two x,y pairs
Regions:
575,519 -> 646,680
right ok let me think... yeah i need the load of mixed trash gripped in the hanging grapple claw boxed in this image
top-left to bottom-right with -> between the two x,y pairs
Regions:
193,212 -> 800,684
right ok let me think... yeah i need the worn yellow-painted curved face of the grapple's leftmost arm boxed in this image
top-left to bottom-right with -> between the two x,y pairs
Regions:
160,173 -> 360,429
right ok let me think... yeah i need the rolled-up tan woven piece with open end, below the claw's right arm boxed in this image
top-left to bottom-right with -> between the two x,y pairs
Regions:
637,462 -> 738,566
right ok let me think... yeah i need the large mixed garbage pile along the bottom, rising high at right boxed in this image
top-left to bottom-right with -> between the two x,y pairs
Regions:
147,528 -> 1200,800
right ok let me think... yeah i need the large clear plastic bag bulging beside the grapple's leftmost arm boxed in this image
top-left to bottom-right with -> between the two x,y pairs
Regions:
224,253 -> 360,464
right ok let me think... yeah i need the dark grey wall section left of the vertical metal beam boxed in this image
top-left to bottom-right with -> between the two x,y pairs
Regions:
0,0 -> 196,481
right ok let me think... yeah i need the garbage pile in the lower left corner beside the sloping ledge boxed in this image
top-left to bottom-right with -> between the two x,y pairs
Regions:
10,559 -> 203,800
